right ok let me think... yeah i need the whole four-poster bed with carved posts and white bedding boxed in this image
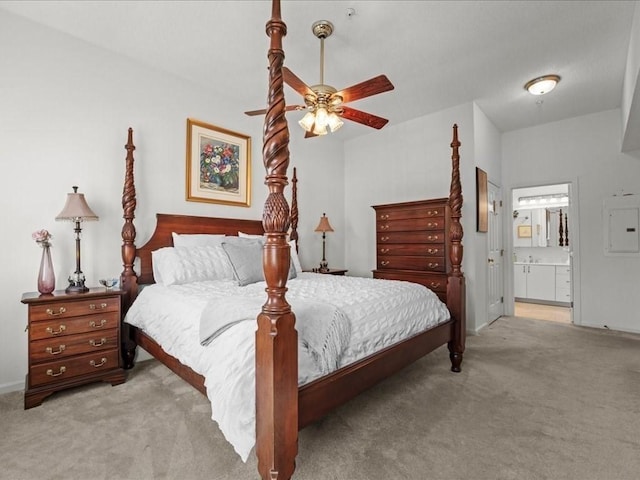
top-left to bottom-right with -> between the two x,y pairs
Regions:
116,0 -> 465,480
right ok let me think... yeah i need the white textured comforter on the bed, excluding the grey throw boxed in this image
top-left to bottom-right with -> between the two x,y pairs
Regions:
125,273 -> 449,461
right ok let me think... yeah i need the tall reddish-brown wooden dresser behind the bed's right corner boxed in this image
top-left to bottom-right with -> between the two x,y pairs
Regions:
373,198 -> 449,302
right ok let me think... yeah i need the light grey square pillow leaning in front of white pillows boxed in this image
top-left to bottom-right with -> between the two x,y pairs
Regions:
222,235 -> 297,287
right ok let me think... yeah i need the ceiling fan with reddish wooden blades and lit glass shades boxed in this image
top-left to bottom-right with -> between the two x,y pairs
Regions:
245,20 -> 394,138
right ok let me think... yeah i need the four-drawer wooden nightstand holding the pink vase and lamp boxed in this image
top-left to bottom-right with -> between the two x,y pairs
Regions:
22,288 -> 125,410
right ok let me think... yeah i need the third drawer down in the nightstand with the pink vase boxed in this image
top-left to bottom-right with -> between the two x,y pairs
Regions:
29,328 -> 119,363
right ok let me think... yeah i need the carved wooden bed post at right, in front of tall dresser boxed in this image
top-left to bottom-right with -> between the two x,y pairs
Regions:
447,124 -> 466,372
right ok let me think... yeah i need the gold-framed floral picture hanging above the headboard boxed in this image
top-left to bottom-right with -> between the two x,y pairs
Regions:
187,118 -> 251,207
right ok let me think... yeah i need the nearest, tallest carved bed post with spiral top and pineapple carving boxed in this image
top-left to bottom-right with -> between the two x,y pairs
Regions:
256,0 -> 298,480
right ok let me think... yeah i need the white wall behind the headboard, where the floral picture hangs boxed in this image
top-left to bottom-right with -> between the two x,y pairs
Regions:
0,11 -> 345,392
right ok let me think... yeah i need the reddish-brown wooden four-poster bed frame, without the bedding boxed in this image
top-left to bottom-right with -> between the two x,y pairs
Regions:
121,0 -> 465,480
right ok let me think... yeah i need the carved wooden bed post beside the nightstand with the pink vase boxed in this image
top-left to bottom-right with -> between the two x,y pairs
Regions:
120,128 -> 138,369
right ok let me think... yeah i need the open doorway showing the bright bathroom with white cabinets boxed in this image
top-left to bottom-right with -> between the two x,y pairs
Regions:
511,183 -> 577,323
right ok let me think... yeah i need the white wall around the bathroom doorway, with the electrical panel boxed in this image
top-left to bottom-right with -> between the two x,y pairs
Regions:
502,109 -> 640,332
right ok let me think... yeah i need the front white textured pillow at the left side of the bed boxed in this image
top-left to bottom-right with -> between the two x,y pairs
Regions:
151,245 -> 234,285
